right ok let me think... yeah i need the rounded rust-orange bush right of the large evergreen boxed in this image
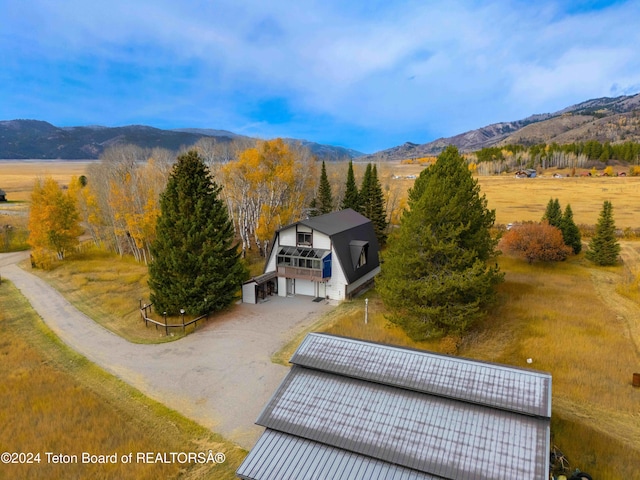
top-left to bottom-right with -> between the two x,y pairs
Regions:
501,222 -> 573,263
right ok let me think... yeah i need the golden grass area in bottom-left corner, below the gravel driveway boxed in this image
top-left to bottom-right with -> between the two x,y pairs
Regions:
0,281 -> 246,480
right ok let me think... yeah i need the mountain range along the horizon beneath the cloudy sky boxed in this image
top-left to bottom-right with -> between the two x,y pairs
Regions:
0,94 -> 640,161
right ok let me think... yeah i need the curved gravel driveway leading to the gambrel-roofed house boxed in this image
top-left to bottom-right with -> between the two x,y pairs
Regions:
0,253 -> 332,449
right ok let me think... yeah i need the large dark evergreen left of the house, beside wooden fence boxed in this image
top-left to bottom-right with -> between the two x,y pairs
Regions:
149,150 -> 247,315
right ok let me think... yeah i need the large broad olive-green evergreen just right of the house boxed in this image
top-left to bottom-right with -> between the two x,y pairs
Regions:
377,147 -> 503,339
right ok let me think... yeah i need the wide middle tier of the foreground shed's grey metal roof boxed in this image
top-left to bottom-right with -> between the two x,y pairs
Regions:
255,366 -> 549,479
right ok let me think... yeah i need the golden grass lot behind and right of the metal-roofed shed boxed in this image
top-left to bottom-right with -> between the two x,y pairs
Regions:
274,251 -> 640,479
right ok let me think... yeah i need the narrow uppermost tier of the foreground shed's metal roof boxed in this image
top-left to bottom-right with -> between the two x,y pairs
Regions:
291,333 -> 551,418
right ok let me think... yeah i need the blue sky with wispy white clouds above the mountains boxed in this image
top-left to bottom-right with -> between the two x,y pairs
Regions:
0,0 -> 640,153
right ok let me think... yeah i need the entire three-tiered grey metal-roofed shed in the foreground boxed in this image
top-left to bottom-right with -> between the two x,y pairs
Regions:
236,333 -> 551,480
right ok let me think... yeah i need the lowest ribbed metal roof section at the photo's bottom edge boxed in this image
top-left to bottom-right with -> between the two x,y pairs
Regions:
236,429 -> 441,480
